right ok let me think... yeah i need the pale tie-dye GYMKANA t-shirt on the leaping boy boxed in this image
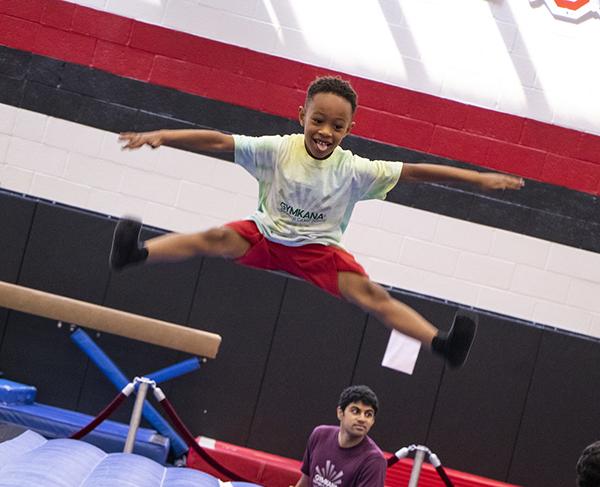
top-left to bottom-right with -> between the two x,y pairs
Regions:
234,134 -> 402,247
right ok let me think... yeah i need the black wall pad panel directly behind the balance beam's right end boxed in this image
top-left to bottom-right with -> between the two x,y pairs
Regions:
172,259 -> 286,444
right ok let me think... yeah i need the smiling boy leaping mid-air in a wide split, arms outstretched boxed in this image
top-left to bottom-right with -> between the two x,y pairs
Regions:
110,76 -> 523,367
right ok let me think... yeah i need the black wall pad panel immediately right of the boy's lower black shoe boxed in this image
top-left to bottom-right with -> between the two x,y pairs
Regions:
427,314 -> 541,479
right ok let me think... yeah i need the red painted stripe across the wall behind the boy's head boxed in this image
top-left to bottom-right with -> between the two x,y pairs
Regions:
0,0 -> 600,194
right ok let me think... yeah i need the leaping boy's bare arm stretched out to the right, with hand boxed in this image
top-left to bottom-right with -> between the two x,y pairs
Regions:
400,163 -> 525,189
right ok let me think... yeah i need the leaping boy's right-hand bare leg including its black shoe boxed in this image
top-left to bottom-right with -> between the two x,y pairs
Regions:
338,272 -> 476,367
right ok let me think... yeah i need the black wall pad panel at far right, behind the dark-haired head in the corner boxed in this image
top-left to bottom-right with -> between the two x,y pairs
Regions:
508,331 -> 600,487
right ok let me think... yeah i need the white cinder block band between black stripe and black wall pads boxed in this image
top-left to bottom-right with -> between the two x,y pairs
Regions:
0,105 -> 600,337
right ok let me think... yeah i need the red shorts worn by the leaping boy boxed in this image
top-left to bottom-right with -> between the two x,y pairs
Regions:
225,220 -> 367,297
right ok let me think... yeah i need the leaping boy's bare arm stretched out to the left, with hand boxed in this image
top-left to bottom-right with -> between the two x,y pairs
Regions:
119,130 -> 234,152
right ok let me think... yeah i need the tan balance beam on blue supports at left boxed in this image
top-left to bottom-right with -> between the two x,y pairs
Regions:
0,281 -> 221,358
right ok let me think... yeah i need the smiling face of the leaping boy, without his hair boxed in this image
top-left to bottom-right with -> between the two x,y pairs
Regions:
298,93 -> 354,159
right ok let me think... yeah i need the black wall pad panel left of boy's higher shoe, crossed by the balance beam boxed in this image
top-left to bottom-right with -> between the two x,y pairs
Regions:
2,203 -> 111,408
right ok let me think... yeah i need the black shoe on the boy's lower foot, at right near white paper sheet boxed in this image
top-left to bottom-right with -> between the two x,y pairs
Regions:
432,313 -> 477,369
